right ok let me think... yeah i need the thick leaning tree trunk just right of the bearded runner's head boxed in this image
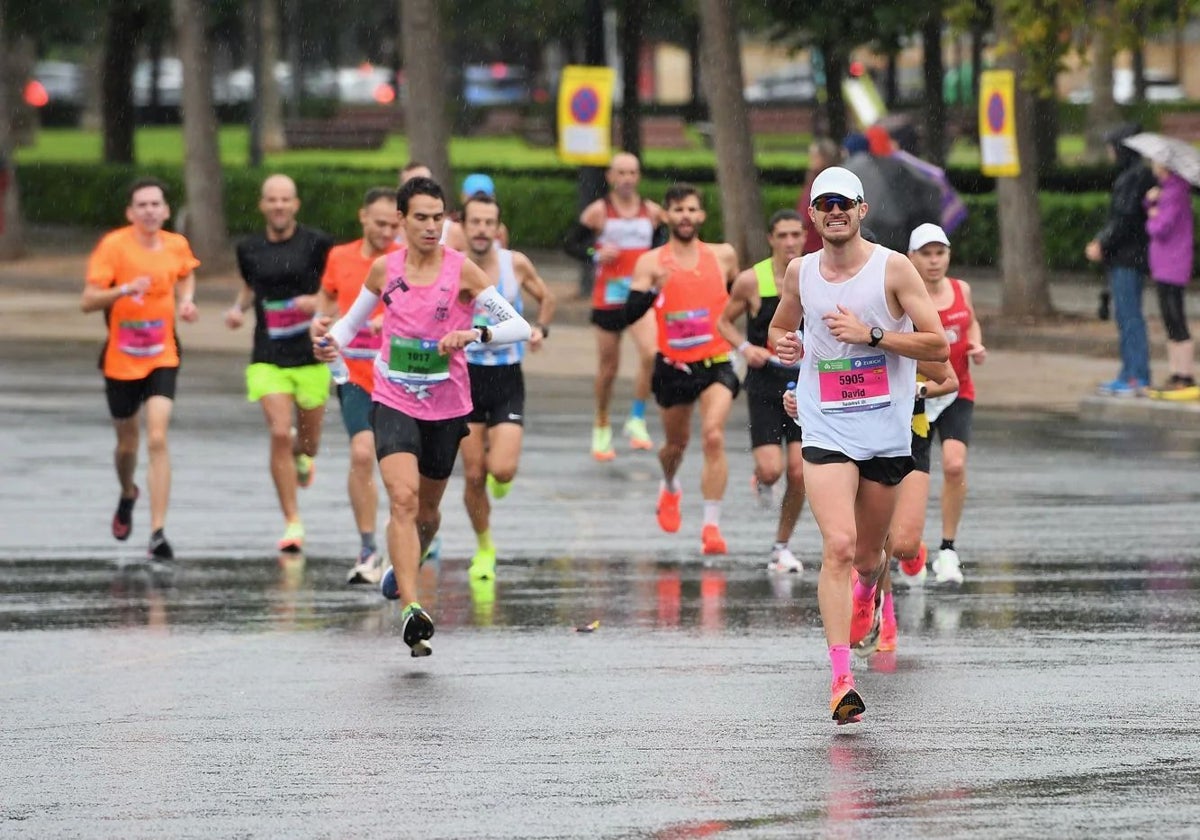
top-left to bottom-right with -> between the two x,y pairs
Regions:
700,0 -> 767,265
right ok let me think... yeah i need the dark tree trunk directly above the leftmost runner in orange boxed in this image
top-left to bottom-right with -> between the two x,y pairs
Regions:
101,0 -> 146,163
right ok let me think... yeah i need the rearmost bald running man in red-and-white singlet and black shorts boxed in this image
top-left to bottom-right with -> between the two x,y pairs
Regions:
571,152 -> 665,461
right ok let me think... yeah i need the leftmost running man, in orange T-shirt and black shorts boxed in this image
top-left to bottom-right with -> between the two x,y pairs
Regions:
80,178 -> 200,560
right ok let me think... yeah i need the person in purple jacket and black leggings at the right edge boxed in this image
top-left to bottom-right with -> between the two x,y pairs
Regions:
1145,162 -> 1200,400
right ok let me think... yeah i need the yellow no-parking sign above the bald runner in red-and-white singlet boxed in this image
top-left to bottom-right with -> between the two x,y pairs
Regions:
558,65 -> 617,167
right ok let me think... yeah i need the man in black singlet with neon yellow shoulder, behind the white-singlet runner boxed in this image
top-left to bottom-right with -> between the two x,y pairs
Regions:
716,210 -> 804,572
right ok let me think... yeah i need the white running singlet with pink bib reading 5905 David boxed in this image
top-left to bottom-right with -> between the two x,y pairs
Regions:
796,245 -> 917,461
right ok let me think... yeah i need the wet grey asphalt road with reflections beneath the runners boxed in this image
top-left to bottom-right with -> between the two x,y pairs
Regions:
0,343 -> 1200,839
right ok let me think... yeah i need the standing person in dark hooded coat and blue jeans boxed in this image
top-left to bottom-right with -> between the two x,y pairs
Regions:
1084,124 -> 1157,396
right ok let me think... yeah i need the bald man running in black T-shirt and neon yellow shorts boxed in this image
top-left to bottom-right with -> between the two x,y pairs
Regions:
226,175 -> 334,551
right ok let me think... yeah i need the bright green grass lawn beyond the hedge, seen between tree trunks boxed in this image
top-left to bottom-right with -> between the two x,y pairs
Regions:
17,126 -> 1099,172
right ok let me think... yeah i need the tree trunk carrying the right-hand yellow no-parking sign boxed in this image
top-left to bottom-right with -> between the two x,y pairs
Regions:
996,4 -> 1054,323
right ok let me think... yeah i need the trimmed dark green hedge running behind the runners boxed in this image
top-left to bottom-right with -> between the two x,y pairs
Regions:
18,164 -> 1200,271
